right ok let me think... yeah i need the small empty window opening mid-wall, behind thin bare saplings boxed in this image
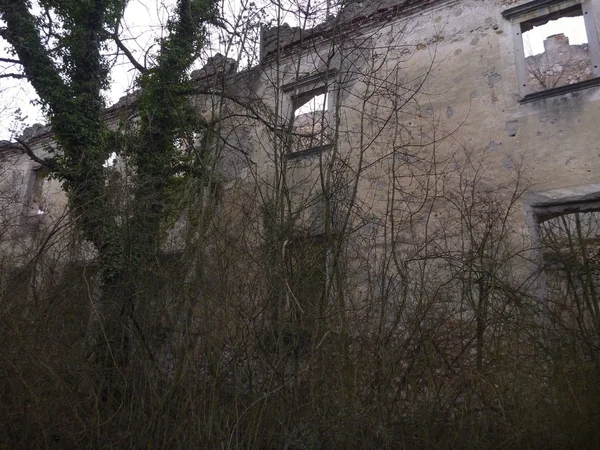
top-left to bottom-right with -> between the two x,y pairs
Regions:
292,91 -> 328,151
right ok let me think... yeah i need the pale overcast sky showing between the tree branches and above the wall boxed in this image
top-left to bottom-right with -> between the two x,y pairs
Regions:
0,0 -> 333,140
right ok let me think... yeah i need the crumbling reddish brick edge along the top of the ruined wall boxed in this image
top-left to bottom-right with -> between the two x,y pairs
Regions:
260,0 -> 459,63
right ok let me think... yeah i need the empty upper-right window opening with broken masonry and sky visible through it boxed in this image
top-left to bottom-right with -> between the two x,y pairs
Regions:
521,5 -> 594,92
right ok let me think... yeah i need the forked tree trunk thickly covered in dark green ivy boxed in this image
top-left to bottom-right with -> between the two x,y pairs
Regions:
0,0 -> 214,395
